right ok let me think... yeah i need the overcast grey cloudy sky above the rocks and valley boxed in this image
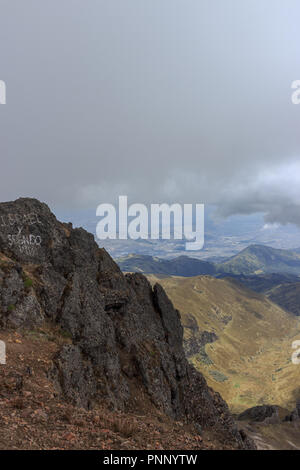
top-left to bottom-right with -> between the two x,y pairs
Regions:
0,0 -> 300,228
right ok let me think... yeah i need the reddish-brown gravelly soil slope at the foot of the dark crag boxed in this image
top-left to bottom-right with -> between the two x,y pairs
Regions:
0,327 -> 226,450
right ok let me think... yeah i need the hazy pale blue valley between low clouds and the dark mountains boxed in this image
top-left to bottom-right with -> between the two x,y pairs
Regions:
61,205 -> 300,263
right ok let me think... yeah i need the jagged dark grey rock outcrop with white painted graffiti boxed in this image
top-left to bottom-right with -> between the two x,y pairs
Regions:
0,198 -> 251,448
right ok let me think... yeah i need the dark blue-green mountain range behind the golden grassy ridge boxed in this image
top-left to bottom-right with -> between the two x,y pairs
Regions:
117,245 -> 300,316
